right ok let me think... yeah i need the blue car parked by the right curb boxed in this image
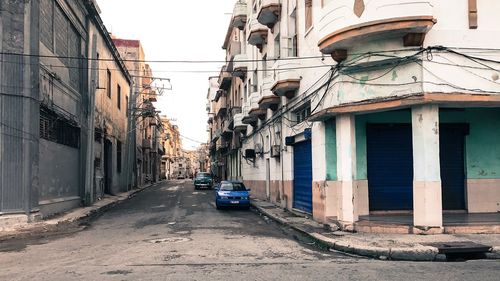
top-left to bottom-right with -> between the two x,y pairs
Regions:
215,181 -> 250,210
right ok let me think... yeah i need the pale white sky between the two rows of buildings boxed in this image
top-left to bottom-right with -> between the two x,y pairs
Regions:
97,0 -> 236,150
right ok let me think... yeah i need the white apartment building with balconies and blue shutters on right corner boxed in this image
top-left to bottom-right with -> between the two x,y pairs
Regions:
213,0 -> 500,233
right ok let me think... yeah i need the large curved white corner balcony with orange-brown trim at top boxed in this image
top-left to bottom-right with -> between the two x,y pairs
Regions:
318,0 -> 436,54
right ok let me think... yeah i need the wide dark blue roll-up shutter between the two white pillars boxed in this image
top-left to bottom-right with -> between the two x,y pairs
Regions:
366,124 -> 413,211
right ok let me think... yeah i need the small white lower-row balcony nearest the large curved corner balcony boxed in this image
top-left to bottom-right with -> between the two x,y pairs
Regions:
271,60 -> 301,99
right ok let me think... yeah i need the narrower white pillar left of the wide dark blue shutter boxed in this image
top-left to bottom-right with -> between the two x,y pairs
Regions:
336,114 -> 358,223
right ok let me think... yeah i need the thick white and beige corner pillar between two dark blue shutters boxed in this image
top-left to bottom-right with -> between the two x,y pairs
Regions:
412,105 -> 443,227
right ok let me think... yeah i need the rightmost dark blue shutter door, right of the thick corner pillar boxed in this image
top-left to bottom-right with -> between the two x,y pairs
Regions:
439,124 -> 468,210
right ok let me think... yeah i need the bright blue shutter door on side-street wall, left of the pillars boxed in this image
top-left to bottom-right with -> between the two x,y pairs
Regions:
293,140 -> 312,213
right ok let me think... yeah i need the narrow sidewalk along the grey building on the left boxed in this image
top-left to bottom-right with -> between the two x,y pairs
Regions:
0,182 -> 161,240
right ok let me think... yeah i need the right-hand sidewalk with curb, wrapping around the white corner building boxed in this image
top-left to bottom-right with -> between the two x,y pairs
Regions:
251,199 -> 500,261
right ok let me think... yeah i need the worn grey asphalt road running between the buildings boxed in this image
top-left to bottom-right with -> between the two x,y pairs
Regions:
0,181 -> 500,281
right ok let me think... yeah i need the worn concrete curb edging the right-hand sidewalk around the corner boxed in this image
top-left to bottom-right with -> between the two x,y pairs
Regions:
251,201 -> 500,261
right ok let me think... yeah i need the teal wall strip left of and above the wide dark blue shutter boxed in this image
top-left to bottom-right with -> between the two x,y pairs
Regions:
356,109 -> 411,180
